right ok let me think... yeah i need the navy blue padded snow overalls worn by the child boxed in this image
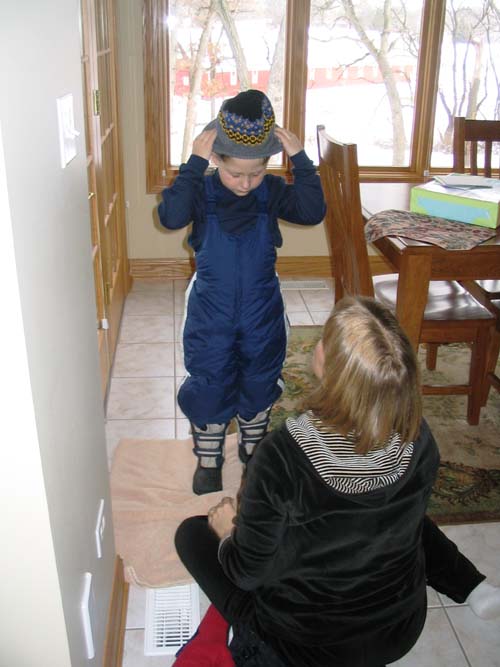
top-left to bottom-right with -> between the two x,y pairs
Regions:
177,176 -> 286,428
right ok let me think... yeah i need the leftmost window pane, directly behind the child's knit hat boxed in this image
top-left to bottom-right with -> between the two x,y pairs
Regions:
168,0 -> 286,164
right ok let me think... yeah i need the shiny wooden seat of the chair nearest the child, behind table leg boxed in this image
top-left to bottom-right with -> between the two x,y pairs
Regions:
373,273 -> 492,321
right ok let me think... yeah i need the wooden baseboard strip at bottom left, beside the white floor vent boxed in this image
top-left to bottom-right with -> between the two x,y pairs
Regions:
102,556 -> 129,667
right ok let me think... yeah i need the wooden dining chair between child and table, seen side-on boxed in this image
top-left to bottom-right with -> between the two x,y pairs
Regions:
317,125 -> 494,424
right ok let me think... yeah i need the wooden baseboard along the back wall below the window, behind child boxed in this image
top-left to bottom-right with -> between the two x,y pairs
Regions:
130,255 -> 391,280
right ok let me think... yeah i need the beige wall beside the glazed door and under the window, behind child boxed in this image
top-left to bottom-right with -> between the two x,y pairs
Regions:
118,0 -> 328,259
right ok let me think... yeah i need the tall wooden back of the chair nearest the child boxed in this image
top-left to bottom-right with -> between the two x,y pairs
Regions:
317,125 -> 373,301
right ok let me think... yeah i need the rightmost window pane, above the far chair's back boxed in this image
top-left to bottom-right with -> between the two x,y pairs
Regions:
432,0 -> 500,168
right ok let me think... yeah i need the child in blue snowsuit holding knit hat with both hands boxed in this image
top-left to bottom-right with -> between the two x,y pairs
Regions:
158,90 -> 325,494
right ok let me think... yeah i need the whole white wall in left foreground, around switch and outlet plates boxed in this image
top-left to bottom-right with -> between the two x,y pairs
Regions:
0,0 -> 114,667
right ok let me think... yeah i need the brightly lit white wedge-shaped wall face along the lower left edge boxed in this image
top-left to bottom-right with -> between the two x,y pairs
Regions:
0,122 -> 70,666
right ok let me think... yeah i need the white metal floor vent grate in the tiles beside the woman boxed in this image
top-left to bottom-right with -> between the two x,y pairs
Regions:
144,584 -> 200,655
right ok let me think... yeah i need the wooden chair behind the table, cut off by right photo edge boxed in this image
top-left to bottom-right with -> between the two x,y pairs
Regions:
453,116 -> 500,404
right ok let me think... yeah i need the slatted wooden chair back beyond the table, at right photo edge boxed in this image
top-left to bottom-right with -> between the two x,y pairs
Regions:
453,116 -> 500,177
